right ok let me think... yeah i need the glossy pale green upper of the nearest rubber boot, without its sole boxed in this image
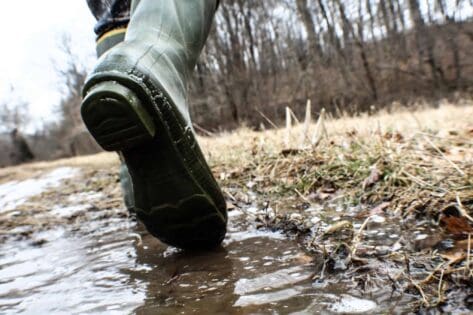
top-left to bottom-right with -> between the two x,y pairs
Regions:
84,0 -> 218,128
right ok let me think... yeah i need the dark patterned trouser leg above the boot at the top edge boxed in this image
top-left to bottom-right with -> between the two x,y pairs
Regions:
87,0 -> 131,37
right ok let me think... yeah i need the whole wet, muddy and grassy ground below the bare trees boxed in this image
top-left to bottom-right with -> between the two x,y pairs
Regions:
0,102 -> 473,314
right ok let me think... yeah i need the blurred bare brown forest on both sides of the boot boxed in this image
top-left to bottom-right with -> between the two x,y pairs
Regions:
0,0 -> 473,166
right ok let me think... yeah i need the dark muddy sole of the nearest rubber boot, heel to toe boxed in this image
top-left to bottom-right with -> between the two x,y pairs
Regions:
81,81 -> 227,249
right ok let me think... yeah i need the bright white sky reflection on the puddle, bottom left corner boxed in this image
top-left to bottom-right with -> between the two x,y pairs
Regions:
0,226 -> 145,314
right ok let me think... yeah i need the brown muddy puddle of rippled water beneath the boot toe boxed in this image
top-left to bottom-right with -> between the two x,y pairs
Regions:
0,168 -> 420,314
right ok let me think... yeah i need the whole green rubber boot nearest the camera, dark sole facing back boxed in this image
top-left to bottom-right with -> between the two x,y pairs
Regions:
81,0 -> 227,249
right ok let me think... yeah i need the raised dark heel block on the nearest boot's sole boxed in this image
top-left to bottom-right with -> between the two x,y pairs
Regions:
81,81 -> 156,151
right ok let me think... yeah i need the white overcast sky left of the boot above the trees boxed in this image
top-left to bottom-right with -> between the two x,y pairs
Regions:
0,0 -> 95,131
